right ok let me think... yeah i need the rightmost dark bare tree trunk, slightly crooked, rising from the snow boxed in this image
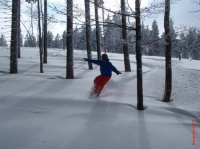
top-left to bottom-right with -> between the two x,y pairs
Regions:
163,0 -> 172,102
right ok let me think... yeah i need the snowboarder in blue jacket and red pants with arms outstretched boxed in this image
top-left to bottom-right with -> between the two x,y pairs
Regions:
83,54 -> 122,96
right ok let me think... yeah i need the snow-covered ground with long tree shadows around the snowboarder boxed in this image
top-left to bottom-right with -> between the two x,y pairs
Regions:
0,48 -> 200,149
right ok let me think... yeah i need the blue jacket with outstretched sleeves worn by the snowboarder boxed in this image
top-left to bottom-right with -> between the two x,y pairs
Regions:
85,59 -> 120,76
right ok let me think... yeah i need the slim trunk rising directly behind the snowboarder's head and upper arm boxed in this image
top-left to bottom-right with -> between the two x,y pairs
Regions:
94,0 -> 101,60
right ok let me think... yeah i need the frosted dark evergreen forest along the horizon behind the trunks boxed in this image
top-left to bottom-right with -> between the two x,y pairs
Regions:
21,15 -> 200,60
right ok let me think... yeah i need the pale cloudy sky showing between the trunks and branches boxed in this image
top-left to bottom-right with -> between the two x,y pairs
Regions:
0,0 -> 200,41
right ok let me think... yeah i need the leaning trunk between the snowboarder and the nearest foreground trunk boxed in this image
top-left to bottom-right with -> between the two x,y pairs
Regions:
121,0 -> 131,72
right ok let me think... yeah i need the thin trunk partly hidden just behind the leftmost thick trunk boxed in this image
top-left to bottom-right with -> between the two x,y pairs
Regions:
18,0 -> 21,58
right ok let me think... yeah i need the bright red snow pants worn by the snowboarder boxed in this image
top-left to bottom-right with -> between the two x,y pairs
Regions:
94,75 -> 111,95
